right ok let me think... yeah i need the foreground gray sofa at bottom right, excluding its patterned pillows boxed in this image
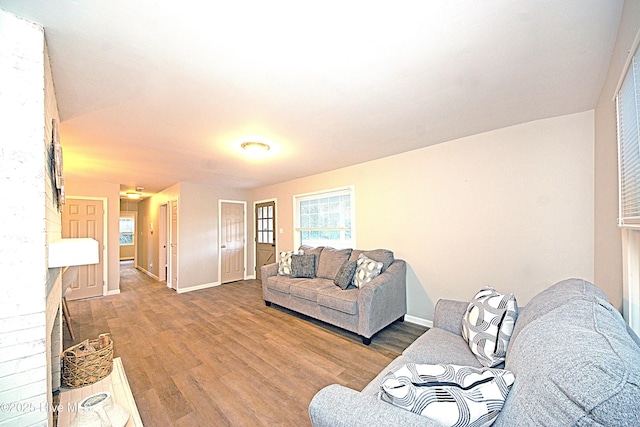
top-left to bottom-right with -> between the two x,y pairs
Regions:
309,279 -> 640,427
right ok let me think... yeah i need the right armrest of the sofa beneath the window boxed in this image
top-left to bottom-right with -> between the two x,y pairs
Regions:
358,259 -> 407,338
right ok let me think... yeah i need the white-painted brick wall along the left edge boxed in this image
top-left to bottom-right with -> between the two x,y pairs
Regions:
0,9 -> 61,427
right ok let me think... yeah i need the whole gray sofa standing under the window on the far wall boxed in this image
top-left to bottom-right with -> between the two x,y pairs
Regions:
260,246 -> 407,345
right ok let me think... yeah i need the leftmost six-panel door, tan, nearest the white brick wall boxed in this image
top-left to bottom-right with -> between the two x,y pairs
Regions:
62,199 -> 104,300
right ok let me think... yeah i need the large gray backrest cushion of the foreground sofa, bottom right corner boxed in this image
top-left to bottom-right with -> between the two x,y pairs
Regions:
495,294 -> 640,427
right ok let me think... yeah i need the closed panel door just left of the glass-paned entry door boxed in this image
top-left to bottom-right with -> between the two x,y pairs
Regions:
220,202 -> 245,283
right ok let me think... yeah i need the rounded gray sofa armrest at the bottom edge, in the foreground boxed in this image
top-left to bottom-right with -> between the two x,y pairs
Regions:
309,384 -> 441,427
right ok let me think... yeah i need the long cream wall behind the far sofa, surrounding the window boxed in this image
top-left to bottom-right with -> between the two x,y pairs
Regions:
253,111 -> 594,319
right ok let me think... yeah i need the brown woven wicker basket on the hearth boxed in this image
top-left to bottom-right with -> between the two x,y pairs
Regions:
62,334 -> 113,388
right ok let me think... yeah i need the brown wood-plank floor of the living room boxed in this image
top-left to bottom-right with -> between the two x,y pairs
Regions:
64,264 -> 426,426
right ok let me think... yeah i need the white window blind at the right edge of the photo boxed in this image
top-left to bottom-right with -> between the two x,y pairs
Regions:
616,51 -> 640,227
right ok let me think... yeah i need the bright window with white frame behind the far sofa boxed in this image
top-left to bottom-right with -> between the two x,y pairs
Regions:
294,187 -> 355,249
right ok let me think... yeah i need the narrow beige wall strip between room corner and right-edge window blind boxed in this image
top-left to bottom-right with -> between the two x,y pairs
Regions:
594,0 -> 640,309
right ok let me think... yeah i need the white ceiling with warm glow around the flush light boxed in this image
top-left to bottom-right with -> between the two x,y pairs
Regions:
0,0 -> 623,196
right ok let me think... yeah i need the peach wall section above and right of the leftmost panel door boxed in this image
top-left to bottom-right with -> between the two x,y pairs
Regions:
65,179 -> 120,294
